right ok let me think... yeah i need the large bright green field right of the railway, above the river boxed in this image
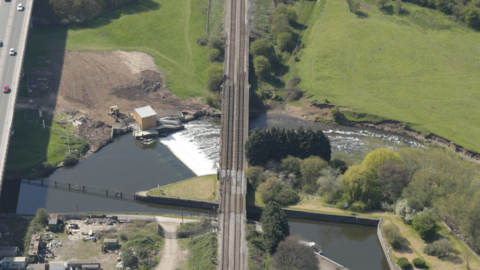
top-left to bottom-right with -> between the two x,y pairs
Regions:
295,0 -> 480,152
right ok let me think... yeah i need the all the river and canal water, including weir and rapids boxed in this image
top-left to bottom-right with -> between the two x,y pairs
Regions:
4,115 -> 419,270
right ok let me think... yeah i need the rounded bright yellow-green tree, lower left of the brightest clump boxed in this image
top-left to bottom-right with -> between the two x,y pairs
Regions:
343,165 -> 381,210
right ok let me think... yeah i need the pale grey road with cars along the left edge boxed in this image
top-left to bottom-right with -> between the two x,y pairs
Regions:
0,0 -> 33,192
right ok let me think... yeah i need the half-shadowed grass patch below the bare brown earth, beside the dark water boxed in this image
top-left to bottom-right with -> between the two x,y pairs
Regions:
6,110 -> 87,174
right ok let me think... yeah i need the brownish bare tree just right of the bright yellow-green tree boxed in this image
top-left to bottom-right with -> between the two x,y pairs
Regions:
377,162 -> 408,202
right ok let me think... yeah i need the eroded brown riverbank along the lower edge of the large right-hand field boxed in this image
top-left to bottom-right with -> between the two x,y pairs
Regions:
267,97 -> 480,164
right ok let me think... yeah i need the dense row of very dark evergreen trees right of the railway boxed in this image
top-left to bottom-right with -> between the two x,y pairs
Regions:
245,127 -> 332,166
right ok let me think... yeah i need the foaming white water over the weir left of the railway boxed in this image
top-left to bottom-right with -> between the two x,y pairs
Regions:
160,118 -> 221,176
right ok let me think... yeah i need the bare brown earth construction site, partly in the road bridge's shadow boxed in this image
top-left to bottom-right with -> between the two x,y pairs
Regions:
17,51 -> 215,152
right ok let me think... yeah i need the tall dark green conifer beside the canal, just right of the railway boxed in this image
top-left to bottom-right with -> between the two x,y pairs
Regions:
260,202 -> 290,254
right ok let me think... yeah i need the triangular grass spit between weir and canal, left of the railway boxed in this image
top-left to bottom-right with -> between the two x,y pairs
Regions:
148,174 -> 217,201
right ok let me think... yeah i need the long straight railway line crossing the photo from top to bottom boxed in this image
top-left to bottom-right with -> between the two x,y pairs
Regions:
217,0 -> 250,270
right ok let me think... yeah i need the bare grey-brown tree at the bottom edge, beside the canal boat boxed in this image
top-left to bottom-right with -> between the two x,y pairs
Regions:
272,235 -> 318,270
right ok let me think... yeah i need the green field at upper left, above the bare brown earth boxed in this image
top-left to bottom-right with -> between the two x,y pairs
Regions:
26,0 -> 218,99
